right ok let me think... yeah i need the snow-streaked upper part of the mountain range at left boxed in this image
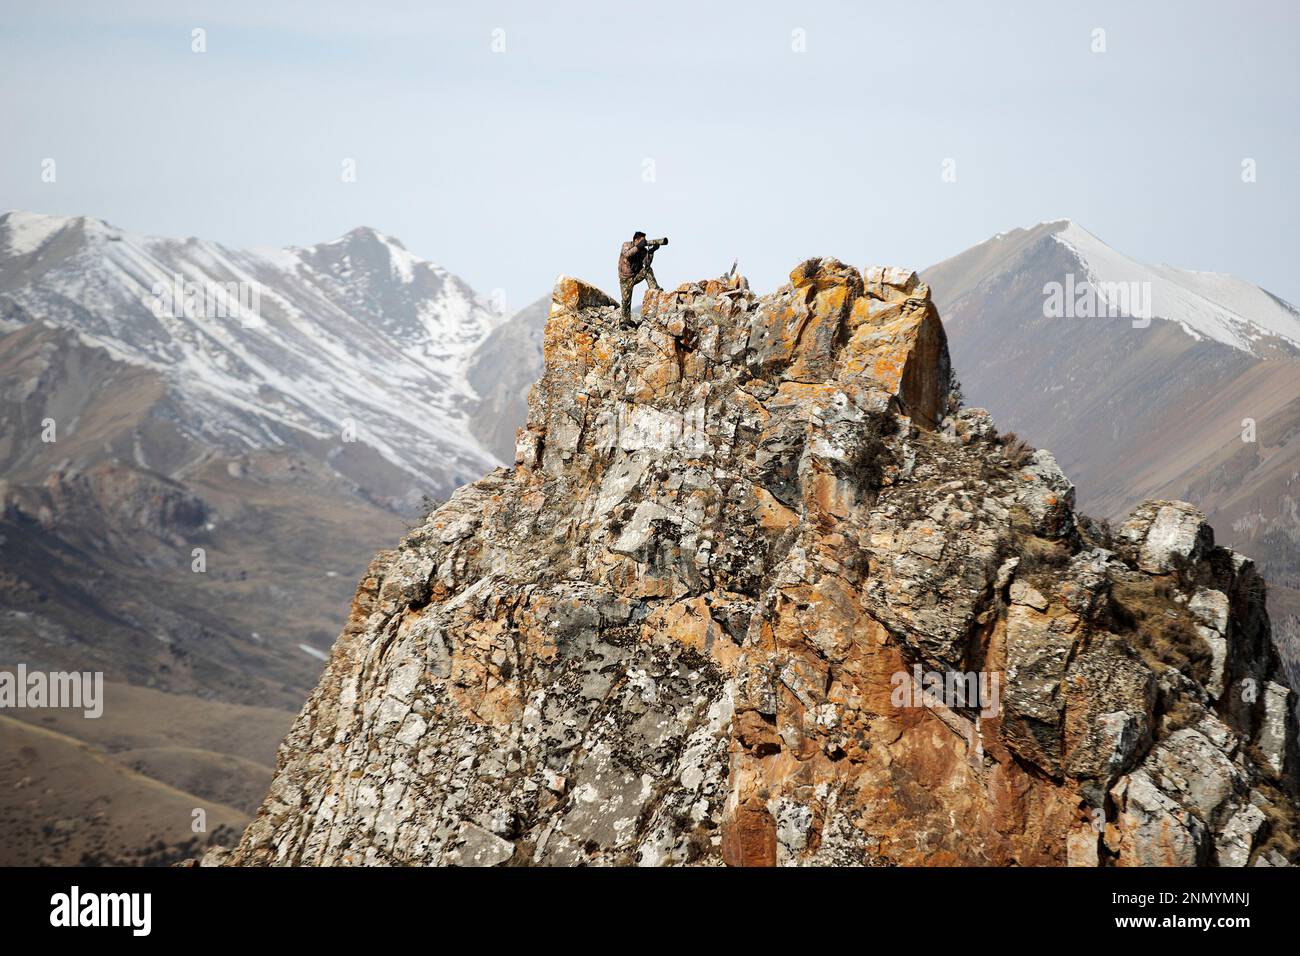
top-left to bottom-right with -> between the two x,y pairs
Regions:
0,212 -> 502,493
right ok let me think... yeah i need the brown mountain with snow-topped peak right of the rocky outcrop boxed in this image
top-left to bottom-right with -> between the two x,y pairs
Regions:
923,220 -> 1300,681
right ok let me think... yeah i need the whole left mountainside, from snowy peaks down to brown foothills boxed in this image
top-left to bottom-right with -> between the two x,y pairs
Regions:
0,212 -> 514,862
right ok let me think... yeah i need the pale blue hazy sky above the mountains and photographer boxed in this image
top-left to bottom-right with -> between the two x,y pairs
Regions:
0,0 -> 1300,308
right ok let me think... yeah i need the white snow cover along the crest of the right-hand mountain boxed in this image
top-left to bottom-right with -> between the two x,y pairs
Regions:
1043,220 -> 1300,355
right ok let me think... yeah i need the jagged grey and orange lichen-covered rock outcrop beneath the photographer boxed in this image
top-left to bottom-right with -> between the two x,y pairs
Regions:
223,259 -> 1300,865
